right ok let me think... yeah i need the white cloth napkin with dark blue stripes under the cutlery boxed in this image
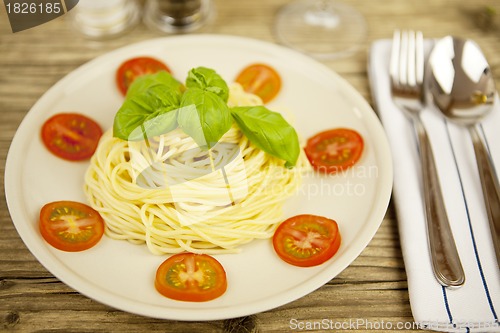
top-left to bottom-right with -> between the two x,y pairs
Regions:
368,40 -> 500,332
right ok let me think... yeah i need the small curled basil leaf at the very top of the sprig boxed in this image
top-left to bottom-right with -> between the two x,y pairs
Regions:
186,67 -> 229,103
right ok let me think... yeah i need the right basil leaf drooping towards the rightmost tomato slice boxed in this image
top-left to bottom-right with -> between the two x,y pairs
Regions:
231,106 -> 300,167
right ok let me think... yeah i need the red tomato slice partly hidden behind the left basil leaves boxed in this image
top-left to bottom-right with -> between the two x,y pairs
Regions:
116,57 -> 171,96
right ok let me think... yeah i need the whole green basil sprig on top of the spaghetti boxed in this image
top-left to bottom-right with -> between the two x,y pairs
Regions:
113,67 -> 300,167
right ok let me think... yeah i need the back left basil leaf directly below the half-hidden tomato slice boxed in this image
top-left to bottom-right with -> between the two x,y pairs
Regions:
127,71 -> 183,98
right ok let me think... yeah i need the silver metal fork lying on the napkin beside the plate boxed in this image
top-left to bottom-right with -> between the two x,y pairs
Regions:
390,30 -> 465,287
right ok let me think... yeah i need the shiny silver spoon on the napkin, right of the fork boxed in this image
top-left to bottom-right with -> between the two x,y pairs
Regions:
427,36 -> 500,267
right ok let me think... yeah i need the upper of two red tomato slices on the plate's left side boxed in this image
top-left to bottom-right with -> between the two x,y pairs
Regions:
42,113 -> 102,161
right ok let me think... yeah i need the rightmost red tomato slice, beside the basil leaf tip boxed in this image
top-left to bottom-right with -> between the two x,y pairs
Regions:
305,128 -> 364,174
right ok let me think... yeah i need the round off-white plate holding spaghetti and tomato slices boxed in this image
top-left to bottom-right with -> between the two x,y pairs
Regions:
5,35 -> 392,320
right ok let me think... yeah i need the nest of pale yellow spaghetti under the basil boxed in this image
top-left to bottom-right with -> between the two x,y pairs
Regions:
85,86 -> 308,254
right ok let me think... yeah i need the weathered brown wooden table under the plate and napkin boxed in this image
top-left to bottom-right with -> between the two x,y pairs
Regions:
0,0 -> 500,332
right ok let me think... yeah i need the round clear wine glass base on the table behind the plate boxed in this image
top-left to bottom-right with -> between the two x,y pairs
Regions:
274,0 -> 367,59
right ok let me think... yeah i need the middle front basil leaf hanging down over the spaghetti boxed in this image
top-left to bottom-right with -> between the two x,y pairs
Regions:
177,87 -> 232,148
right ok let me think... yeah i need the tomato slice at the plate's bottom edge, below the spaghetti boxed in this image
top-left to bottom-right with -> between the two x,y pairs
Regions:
155,253 -> 227,302
